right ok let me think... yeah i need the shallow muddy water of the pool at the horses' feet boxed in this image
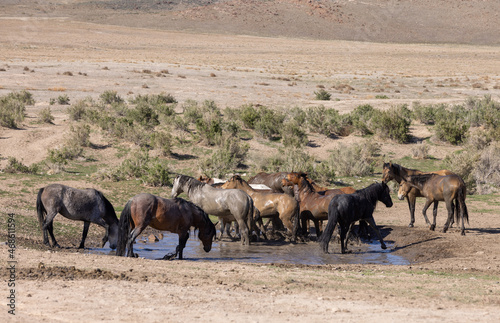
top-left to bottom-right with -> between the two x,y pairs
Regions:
90,232 -> 410,265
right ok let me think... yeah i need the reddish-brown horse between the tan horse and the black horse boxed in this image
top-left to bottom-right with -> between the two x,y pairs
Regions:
282,173 -> 345,237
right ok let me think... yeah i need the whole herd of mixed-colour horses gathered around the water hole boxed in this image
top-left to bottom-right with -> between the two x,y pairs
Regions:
36,163 -> 468,259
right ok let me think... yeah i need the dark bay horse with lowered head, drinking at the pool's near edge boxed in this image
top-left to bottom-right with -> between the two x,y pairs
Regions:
116,193 -> 216,260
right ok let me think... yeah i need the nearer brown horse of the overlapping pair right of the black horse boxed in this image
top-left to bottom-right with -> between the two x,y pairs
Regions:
398,174 -> 469,235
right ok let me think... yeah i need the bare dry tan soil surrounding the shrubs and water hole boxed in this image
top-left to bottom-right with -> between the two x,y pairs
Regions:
0,1 -> 500,322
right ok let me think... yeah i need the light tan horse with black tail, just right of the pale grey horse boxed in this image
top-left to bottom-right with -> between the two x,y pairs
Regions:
222,175 -> 299,241
